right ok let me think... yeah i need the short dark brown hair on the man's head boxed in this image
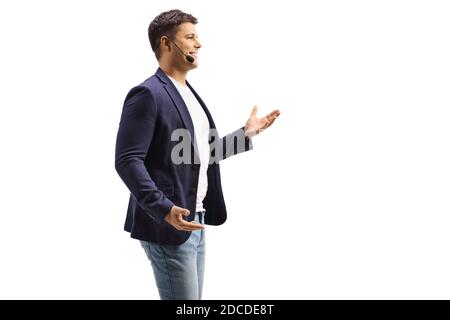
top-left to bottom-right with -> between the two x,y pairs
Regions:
148,9 -> 197,60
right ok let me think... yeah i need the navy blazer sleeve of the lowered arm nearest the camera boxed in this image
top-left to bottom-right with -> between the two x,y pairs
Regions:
115,86 -> 174,223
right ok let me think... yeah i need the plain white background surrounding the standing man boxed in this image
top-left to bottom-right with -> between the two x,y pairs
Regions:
0,0 -> 450,299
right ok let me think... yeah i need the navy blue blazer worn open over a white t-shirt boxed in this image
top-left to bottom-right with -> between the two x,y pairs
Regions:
115,68 -> 252,244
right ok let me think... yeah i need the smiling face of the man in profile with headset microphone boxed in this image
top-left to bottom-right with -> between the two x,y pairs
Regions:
164,22 -> 202,69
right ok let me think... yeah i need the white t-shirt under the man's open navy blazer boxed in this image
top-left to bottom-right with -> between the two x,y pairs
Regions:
168,76 -> 210,211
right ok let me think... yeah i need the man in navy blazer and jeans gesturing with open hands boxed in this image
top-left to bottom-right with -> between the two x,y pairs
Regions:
115,10 -> 280,300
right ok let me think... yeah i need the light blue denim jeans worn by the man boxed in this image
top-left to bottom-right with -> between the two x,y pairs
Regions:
141,212 -> 205,300
